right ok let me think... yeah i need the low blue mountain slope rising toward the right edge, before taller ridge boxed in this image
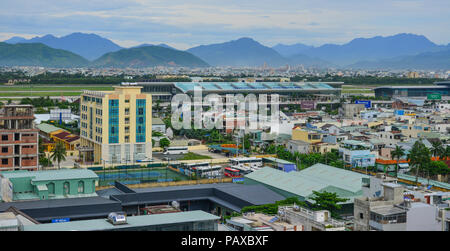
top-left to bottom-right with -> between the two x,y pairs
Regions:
348,49 -> 450,70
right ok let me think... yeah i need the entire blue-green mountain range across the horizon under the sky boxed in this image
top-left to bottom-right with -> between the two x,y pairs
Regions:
0,33 -> 450,69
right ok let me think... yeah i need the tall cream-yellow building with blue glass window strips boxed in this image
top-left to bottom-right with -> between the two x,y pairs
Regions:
79,85 -> 152,164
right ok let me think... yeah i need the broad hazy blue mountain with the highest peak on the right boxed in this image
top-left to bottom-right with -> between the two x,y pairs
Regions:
302,33 -> 445,65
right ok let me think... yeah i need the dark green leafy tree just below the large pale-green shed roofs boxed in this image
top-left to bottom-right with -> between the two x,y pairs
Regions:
310,191 -> 348,217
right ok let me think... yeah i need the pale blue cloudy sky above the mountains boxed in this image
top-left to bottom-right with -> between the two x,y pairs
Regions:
0,0 -> 450,49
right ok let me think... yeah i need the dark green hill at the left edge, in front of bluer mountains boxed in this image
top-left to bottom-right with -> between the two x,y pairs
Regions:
0,42 -> 89,68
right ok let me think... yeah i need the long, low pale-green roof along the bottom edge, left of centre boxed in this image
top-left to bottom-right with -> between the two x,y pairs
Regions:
24,210 -> 220,231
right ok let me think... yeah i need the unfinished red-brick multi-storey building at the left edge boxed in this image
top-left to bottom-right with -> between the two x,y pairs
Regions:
0,105 -> 39,171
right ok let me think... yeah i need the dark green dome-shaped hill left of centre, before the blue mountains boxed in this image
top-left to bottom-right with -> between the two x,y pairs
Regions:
92,46 -> 208,68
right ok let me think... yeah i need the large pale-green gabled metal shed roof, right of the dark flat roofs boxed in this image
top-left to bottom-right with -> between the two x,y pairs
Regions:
245,164 -> 368,203
